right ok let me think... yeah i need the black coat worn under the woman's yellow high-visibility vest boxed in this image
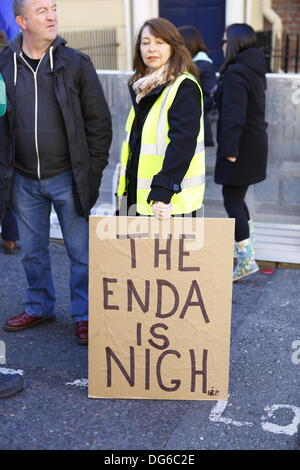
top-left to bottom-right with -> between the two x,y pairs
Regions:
127,79 -> 202,204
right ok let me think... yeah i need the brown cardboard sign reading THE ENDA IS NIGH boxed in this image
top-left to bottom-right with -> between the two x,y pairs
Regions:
89,217 -> 234,400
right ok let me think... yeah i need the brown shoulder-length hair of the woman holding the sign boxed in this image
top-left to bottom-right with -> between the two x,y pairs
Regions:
130,18 -> 199,82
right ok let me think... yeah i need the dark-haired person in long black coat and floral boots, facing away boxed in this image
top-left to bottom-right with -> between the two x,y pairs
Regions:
215,23 -> 268,281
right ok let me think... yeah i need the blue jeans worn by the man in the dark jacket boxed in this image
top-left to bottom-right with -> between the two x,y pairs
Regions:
12,171 -> 88,321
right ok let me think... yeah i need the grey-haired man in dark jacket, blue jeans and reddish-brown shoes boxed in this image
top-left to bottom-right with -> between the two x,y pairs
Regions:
0,0 -> 112,344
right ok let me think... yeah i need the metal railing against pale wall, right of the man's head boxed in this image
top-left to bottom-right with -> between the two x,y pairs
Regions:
61,28 -> 118,70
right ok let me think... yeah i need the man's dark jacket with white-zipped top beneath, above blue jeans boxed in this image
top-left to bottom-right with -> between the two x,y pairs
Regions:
0,34 -> 112,218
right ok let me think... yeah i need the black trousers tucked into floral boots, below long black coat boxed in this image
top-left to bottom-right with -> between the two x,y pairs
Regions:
222,185 -> 250,242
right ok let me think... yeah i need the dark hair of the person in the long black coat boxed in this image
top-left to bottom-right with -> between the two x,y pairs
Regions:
220,23 -> 257,74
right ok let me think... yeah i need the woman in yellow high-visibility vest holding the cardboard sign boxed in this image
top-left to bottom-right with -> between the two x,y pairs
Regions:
117,18 -> 205,219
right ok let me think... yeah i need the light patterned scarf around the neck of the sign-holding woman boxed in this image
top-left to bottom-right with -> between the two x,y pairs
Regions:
132,64 -> 175,103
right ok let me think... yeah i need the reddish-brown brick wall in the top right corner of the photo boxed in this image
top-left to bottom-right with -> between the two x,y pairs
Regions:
272,0 -> 300,72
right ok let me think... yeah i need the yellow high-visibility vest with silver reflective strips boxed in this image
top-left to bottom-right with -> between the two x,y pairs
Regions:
117,73 -> 205,215
